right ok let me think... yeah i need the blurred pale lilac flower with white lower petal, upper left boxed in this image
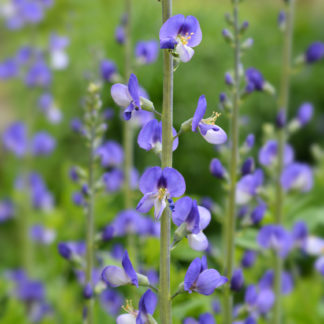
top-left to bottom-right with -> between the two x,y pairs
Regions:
49,34 -> 70,70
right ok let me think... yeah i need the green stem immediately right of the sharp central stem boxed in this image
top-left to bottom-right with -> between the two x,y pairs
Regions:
224,0 -> 240,324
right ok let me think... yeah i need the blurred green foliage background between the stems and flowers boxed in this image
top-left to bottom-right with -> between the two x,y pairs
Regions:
0,0 -> 324,324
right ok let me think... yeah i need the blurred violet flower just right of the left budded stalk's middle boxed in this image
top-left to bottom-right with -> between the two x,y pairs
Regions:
96,141 -> 124,168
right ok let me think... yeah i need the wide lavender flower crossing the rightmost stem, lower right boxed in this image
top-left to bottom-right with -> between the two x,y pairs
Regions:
257,225 -> 293,258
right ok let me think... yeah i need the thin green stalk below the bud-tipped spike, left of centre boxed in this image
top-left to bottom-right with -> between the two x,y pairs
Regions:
86,125 -> 95,324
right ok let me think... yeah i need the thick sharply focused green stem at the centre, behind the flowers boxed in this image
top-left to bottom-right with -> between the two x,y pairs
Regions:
159,0 -> 173,324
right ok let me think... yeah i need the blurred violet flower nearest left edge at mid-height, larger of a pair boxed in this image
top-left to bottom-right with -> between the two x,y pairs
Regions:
2,122 -> 28,157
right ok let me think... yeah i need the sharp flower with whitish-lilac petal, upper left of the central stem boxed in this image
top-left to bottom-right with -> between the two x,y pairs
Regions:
110,73 -> 141,120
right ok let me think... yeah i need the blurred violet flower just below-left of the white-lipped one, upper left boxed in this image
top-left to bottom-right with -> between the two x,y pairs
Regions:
25,60 -> 52,87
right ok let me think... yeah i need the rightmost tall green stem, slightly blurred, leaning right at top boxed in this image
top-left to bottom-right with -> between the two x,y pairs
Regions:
273,0 -> 295,324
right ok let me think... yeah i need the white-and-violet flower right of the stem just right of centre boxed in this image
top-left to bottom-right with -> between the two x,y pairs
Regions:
236,169 -> 263,205
